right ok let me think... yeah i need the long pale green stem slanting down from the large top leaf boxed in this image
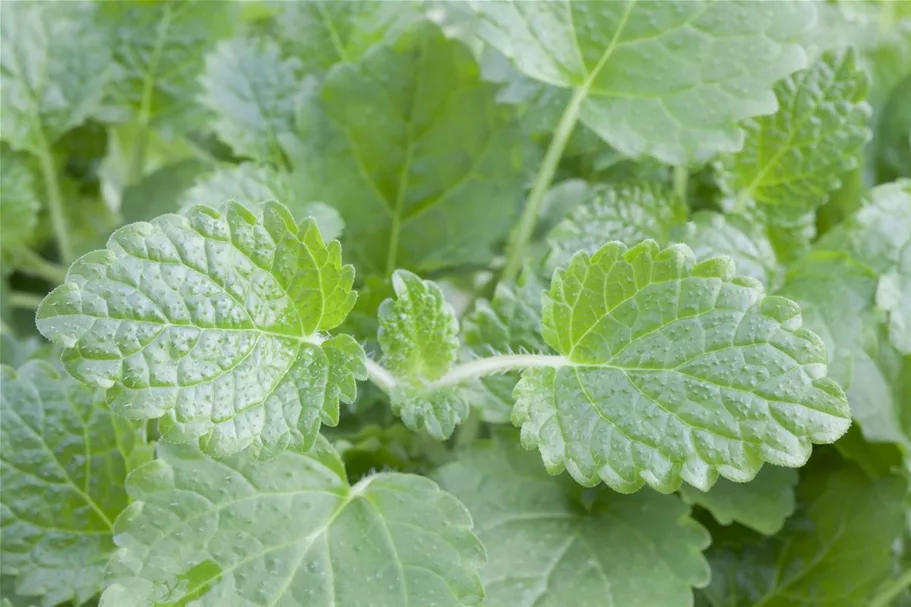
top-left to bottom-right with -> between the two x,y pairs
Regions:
500,86 -> 589,282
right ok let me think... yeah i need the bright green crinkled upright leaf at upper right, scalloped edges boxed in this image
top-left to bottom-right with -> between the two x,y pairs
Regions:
718,52 -> 870,229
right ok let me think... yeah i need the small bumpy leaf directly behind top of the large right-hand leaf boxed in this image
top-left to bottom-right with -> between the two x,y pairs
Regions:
547,184 -> 687,268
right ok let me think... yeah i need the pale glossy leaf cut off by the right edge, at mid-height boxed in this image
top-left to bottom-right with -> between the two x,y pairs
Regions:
817,179 -> 911,354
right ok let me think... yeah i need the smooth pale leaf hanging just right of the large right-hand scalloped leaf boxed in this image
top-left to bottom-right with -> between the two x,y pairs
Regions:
779,251 -> 911,446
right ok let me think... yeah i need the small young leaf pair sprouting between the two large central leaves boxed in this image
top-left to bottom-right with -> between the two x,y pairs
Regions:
377,270 -> 468,440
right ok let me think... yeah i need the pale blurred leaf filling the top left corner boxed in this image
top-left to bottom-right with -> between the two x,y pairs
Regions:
0,1 -> 110,155
